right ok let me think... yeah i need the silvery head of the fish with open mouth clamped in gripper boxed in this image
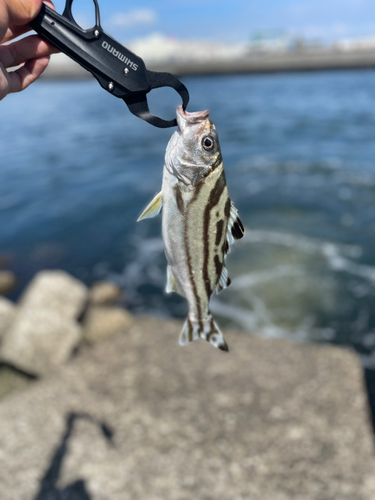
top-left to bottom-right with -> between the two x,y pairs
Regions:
166,106 -> 222,186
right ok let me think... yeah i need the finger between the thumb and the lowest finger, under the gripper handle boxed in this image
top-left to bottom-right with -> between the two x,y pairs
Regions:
0,35 -> 58,68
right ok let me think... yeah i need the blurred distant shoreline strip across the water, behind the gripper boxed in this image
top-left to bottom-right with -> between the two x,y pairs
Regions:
39,50 -> 375,80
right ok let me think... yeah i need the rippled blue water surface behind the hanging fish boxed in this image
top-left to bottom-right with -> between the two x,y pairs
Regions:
0,70 -> 375,368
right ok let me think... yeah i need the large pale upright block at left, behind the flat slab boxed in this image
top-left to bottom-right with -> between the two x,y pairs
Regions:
0,271 -> 88,375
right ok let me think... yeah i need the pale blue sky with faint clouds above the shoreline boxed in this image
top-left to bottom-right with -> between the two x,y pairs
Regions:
51,0 -> 375,42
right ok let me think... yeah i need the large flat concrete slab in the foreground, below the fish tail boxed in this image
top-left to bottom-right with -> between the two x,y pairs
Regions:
0,319 -> 375,500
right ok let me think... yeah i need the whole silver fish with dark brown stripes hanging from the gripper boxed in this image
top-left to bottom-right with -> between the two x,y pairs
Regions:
138,106 -> 244,351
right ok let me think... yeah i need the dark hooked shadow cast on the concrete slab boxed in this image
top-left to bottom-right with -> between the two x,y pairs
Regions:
34,413 -> 113,500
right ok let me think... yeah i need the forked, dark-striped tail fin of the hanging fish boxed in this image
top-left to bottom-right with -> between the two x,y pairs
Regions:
180,314 -> 229,352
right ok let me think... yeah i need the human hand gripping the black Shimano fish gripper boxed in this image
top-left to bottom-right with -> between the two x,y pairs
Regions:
0,0 -> 58,101
